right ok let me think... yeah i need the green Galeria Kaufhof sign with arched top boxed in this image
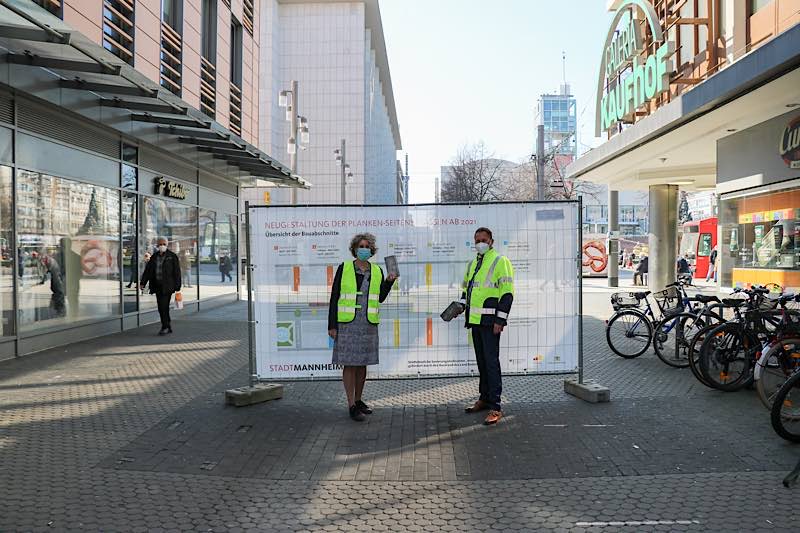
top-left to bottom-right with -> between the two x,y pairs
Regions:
595,0 -> 675,137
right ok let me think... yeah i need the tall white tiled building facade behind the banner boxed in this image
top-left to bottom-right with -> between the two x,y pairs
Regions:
258,0 -> 401,204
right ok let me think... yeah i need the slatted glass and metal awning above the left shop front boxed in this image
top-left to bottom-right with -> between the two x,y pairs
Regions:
0,0 -> 311,189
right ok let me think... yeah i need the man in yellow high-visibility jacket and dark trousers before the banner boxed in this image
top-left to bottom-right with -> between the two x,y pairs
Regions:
461,228 -> 514,425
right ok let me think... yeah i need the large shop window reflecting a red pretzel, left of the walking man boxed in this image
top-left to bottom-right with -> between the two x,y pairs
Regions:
16,170 -> 120,331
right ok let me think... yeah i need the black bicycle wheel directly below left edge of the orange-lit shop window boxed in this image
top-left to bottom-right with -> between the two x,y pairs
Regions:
700,322 -> 758,392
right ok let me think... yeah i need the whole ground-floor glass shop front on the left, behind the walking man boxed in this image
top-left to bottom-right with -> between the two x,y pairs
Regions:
0,154 -> 239,337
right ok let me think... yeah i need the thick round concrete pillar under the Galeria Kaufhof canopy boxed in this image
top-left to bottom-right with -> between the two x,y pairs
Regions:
647,185 -> 678,291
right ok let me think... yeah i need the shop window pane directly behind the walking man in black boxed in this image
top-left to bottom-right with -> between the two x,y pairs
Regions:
138,196 -> 197,310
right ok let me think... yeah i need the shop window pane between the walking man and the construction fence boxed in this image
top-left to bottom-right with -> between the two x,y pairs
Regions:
199,209 -> 238,298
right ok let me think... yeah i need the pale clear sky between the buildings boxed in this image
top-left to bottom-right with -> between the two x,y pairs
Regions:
380,0 -> 612,203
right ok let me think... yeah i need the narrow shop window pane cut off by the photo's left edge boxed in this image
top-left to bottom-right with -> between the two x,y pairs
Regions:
0,166 -> 13,337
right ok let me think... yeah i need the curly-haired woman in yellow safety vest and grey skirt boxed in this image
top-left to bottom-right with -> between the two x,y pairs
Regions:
328,233 -> 397,422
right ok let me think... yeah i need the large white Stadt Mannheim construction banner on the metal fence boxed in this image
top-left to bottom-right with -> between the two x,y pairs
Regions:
250,202 -> 581,380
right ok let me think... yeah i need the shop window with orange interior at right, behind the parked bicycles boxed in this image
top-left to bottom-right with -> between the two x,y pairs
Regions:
719,184 -> 800,290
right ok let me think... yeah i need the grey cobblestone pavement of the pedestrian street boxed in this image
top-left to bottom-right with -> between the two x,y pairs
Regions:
0,291 -> 800,531
